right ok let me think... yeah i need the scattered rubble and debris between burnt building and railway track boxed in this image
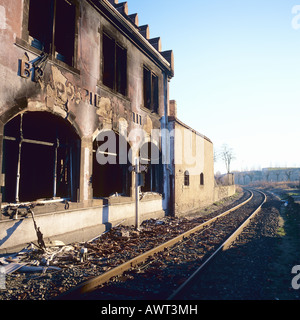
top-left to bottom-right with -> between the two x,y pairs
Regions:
0,192 -> 246,300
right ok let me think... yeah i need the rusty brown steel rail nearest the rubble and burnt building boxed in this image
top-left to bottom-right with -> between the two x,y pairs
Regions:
56,190 -> 253,299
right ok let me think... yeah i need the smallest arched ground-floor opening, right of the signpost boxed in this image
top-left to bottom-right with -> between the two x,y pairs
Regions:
140,142 -> 163,194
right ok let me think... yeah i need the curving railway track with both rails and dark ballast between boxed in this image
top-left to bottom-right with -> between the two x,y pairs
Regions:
58,190 -> 266,300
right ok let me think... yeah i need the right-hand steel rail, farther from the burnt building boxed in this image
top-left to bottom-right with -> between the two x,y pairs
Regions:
167,190 -> 267,300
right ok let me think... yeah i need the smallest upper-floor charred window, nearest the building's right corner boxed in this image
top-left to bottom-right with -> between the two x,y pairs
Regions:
143,67 -> 159,113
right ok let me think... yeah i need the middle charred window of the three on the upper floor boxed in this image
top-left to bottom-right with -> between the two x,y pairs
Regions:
103,33 -> 127,96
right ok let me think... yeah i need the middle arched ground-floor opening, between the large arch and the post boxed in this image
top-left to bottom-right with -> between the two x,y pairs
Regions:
92,134 -> 131,198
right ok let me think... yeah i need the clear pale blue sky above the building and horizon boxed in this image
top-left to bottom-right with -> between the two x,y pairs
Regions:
128,0 -> 300,172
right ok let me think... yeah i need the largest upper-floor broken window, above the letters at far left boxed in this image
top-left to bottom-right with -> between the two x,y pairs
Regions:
28,0 -> 76,65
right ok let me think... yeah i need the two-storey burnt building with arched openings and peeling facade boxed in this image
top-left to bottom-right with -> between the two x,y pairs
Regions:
0,0 -> 234,251
